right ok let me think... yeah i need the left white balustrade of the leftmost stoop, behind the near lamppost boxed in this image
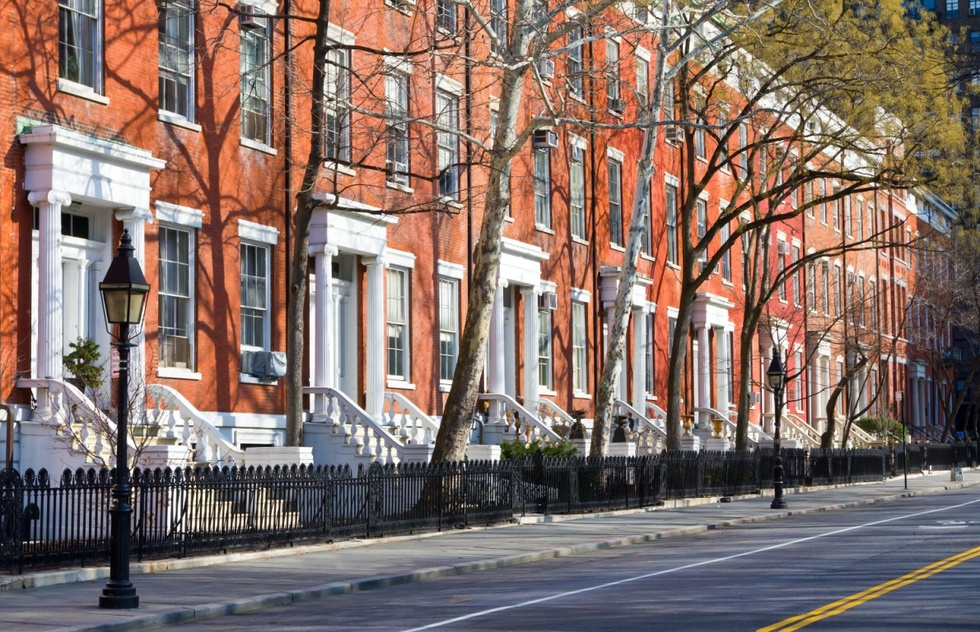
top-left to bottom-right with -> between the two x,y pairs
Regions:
17,378 -> 128,467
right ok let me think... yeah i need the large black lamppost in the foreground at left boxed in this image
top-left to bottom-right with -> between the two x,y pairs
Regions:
99,230 -> 150,610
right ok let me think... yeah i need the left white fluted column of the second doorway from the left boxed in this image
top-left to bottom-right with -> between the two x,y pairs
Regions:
311,246 -> 337,417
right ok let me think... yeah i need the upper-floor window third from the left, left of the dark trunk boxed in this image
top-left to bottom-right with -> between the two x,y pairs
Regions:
239,11 -> 272,145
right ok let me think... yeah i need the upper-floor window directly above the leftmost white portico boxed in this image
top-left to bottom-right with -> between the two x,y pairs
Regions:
58,0 -> 102,92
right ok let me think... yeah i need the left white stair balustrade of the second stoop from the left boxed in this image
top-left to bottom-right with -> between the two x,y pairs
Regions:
303,386 -> 402,465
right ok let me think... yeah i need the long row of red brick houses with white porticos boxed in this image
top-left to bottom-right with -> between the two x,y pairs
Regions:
0,0 -> 948,474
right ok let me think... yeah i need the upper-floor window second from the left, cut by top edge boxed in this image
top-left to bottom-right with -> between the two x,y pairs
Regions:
157,0 -> 194,121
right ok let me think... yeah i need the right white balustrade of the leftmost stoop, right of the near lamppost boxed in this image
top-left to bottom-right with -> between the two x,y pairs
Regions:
146,384 -> 246,467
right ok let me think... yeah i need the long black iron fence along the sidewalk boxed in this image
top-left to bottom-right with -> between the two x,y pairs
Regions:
0,445 -> 977,572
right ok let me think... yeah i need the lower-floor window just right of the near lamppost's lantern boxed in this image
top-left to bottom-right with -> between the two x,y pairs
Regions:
157,226 -> 194,370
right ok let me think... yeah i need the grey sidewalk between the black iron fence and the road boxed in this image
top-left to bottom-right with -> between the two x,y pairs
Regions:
0,470 -> 980,632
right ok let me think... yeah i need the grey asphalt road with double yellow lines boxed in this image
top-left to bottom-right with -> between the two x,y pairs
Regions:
172,489 -> 980,632
